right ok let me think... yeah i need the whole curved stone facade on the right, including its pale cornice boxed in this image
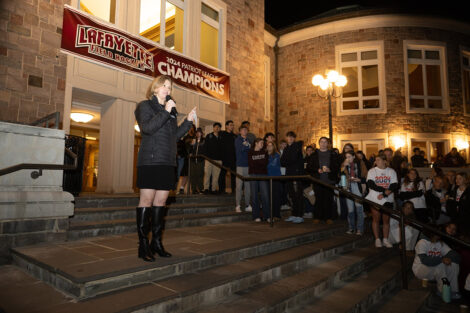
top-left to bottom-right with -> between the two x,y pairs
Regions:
268,12 -> 470,160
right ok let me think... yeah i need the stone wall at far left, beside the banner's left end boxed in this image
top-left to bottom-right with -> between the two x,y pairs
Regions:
0,0 -> 69,123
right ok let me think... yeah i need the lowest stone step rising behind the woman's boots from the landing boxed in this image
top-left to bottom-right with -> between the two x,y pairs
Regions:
67,211 -> 252,240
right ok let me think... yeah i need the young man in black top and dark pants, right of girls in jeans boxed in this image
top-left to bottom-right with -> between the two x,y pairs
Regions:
281,131 -> 304,223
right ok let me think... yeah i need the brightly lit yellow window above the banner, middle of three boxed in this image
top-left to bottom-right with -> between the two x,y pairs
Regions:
139,0 -> 185,52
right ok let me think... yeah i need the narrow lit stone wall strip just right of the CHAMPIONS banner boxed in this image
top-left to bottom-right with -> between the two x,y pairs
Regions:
225,0 -> 274,136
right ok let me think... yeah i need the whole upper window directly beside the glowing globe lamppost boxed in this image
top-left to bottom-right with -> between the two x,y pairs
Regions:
337,42 -> 385,115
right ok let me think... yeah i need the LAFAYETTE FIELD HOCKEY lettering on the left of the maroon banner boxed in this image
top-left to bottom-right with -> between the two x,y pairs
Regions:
75,25 -> 154,71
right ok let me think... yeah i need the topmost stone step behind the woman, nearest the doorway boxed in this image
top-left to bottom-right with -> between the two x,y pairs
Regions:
75,194 -> 235,208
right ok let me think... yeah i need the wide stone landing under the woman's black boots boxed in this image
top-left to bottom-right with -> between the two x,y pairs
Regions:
12,222 -> 348,299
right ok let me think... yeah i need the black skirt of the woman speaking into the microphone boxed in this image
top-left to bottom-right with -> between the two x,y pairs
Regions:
137,165 -> 176,190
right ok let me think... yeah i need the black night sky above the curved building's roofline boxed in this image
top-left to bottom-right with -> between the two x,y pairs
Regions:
264,0 -> 470,29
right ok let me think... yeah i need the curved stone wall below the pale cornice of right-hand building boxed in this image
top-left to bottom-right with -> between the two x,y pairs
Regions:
278,27 -> 470,147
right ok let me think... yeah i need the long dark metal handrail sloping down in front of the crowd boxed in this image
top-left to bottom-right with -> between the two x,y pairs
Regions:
188,154 -> 470,289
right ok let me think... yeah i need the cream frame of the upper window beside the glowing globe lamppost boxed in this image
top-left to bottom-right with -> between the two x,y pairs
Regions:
335,40 -> 387,116
